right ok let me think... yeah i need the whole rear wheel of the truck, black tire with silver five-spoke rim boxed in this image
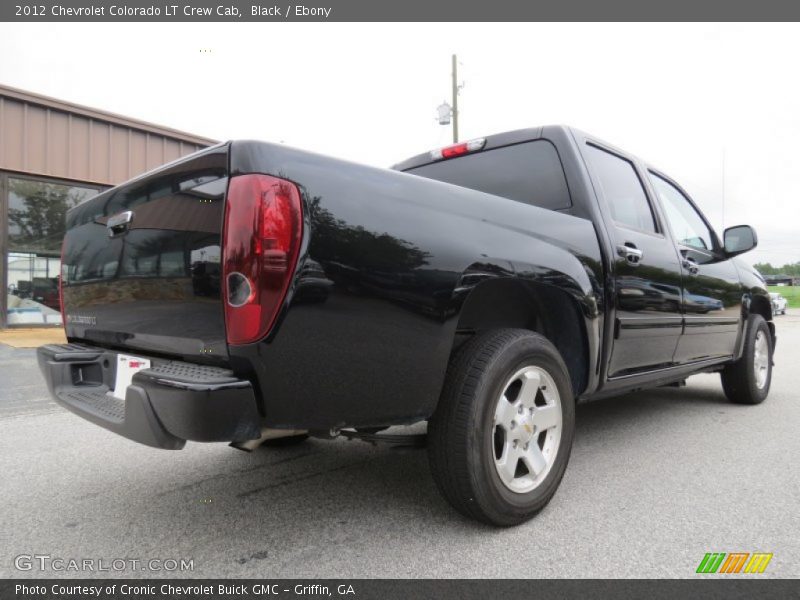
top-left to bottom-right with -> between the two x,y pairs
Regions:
428,329 -> 575,527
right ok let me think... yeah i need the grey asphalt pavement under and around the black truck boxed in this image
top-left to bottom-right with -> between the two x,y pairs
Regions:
0,310 -> 800,578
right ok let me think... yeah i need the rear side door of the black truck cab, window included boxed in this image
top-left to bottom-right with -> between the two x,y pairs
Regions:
584,143 -> 682,377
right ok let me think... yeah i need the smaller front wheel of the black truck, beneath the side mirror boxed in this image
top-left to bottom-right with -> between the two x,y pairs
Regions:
721,315 -> 772,404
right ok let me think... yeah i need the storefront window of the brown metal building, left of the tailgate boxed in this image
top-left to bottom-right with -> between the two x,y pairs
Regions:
6,177 -> 99,325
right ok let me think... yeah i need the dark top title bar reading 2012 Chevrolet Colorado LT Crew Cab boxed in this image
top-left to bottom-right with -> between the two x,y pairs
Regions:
0,0 -> 800,21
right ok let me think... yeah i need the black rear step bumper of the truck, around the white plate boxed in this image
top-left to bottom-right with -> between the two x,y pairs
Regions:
37,344 -> 261,450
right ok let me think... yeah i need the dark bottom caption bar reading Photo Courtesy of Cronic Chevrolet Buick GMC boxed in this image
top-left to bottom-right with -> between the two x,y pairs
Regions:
0,575 -> 798,600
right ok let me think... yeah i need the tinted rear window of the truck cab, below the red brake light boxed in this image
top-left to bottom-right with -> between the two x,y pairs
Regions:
407,140 -> 572,210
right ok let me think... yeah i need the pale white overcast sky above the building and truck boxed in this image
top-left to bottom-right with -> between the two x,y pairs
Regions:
0,23 -> 800,265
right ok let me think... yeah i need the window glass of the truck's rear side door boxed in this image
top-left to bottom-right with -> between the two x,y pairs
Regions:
586,145 -> 656,233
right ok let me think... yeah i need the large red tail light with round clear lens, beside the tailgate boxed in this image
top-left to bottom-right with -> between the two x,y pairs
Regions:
222,175 -> 303,344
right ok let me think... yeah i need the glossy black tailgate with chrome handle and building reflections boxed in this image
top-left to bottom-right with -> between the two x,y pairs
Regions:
61,145 -> 228,363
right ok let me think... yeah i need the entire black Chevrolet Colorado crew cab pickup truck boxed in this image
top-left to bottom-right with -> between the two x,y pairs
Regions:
38,126 -> 775,525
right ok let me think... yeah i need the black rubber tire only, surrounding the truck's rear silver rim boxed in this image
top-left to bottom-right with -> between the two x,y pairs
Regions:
428,329 -> 575,527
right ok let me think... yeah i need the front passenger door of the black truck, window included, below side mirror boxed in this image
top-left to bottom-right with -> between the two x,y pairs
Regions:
648,170 -> 742,363
